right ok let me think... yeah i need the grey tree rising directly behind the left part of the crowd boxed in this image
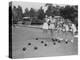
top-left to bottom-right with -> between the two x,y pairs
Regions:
45,3 -> 60,16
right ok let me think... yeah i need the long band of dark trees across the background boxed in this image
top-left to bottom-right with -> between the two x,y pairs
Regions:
12,3 -> 78,26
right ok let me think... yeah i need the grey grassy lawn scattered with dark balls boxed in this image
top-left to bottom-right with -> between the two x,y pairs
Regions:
12,26 -> 78,58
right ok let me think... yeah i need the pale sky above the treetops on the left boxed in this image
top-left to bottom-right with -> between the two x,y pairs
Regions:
12,1 -> 45,12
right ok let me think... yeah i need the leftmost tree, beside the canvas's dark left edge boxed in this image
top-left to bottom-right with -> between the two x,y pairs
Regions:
12,6 -> 23,24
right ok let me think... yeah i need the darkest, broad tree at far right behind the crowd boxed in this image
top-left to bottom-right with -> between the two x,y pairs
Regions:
60,5 -> 78,23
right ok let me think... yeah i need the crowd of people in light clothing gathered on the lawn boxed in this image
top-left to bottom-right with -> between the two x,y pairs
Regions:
42,15 -> 77,34
